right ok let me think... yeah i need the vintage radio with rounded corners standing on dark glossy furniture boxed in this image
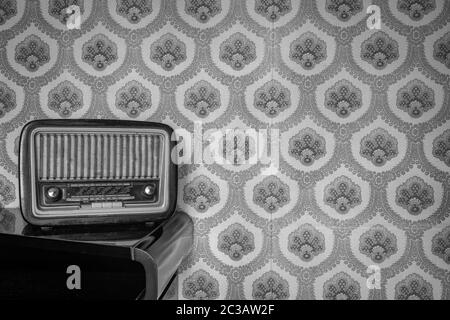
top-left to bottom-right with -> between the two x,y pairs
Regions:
19,120 -> 177,226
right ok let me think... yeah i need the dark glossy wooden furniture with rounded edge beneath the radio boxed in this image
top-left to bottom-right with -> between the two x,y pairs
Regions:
0,209 -> 193,299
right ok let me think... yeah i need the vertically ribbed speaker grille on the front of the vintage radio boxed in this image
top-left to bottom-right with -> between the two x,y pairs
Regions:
35,132 -> 161,181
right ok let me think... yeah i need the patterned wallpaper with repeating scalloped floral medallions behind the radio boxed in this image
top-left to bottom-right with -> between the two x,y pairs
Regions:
0,0 -> 450,299
